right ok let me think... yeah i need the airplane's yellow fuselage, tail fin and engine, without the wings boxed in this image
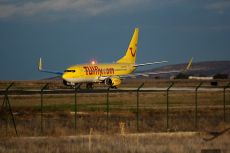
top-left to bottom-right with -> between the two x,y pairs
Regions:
62,28 -> 139,86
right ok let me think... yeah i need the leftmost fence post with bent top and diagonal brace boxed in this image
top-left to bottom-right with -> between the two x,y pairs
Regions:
1,82 -> 18,136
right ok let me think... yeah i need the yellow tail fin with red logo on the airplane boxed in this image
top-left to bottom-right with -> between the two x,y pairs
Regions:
117,28 -> 139,64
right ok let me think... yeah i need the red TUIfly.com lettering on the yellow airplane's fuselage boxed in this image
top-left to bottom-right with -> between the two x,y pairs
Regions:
83,66 -> 114,75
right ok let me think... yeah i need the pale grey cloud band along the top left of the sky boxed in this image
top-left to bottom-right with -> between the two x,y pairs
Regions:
0,0 -> 145,18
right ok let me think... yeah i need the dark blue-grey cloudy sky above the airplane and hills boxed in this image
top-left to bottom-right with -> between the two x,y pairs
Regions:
0,0 -> 230,80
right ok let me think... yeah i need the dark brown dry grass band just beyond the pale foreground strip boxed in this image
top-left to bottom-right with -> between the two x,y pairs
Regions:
0,109 -> 230,136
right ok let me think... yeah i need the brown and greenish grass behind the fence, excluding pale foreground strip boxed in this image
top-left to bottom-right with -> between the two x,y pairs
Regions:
0,80 -> 230,136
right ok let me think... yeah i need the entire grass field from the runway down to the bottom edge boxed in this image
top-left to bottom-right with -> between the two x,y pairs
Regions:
0,80 -> 230,153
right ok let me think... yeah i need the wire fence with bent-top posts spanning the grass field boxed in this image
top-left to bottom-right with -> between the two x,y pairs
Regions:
0,82 -> 230,136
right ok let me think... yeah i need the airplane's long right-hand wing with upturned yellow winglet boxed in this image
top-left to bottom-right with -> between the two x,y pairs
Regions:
119,58 -> 193,78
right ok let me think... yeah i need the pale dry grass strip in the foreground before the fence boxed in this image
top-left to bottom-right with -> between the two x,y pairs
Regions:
0,132 -> 230,153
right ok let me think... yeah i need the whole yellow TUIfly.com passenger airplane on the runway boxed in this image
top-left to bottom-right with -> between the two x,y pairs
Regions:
38,28 -> 190,89
